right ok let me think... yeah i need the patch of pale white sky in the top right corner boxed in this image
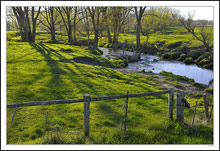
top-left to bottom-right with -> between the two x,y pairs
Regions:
172,7 -> 214,20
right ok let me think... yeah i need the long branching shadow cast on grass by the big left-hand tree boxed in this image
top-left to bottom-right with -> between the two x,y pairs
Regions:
30,43 -> 102,99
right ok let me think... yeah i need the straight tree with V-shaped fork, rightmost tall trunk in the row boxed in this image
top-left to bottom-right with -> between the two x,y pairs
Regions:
134,7 -> 147,49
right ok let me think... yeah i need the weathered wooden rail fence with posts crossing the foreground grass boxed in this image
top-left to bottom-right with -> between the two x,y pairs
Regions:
7,88 -> 185,137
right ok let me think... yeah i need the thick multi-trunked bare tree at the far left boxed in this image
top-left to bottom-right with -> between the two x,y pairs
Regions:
12,7 -> 41,42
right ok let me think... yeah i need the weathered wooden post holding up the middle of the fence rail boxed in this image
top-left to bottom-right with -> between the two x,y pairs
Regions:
84,94 -> 90,137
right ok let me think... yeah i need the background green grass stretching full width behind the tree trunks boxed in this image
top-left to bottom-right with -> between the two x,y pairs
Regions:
7,26 -> 213,69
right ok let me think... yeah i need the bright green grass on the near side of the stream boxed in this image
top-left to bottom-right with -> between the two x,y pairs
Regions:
7,36 -> 213,144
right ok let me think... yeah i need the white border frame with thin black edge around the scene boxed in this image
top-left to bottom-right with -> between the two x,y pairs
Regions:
1,1 -> 219,150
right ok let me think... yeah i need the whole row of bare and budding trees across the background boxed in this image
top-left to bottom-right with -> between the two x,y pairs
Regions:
8,7 -> 210,49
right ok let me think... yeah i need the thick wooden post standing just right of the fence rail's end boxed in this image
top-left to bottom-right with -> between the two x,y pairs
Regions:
176,93 -> 185,123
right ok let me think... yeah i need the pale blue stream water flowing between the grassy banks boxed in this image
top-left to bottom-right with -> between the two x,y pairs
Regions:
99,47 -> 213,87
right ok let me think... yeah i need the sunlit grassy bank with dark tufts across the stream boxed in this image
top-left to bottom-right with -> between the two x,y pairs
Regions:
99,27 -> 213,69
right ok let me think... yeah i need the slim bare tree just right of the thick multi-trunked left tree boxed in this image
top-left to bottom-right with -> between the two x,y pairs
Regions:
41,7 -> 60,43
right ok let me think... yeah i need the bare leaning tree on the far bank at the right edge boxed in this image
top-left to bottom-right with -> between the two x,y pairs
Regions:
179,13 -> 213,51
